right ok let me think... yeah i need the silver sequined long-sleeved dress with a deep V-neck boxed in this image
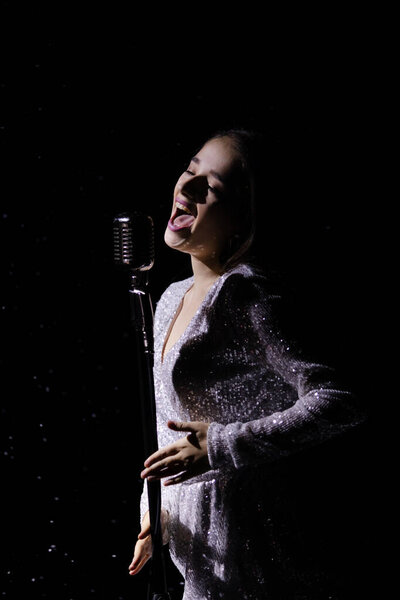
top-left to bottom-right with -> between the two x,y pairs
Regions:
141,265 -> 363,600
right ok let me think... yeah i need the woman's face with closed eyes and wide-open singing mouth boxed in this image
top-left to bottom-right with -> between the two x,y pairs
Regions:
164,137 -> 239,264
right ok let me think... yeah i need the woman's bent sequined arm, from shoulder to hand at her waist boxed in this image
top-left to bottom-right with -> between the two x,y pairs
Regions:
142,275 -> 364,485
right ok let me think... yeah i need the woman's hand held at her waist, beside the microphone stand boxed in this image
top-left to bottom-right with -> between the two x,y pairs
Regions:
140,421 -> 211,485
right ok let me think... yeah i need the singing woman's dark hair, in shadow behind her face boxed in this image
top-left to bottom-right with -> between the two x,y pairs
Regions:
208,129 -> 266,271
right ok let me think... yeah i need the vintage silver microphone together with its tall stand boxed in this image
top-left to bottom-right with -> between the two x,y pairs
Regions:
113,213 -> 170,600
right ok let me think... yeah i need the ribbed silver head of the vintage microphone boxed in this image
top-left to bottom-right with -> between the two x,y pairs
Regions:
113,212 -> 154,271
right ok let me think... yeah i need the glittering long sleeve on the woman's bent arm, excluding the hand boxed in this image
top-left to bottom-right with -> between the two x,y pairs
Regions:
208,274 -> 365,469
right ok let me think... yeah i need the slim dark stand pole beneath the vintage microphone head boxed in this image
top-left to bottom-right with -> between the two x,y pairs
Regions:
129,270 -> 170,600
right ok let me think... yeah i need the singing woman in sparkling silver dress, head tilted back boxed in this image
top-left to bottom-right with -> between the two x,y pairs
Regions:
129,130 -> 361,600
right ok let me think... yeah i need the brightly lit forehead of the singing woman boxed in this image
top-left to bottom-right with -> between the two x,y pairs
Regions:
196,137 -> 239,178
